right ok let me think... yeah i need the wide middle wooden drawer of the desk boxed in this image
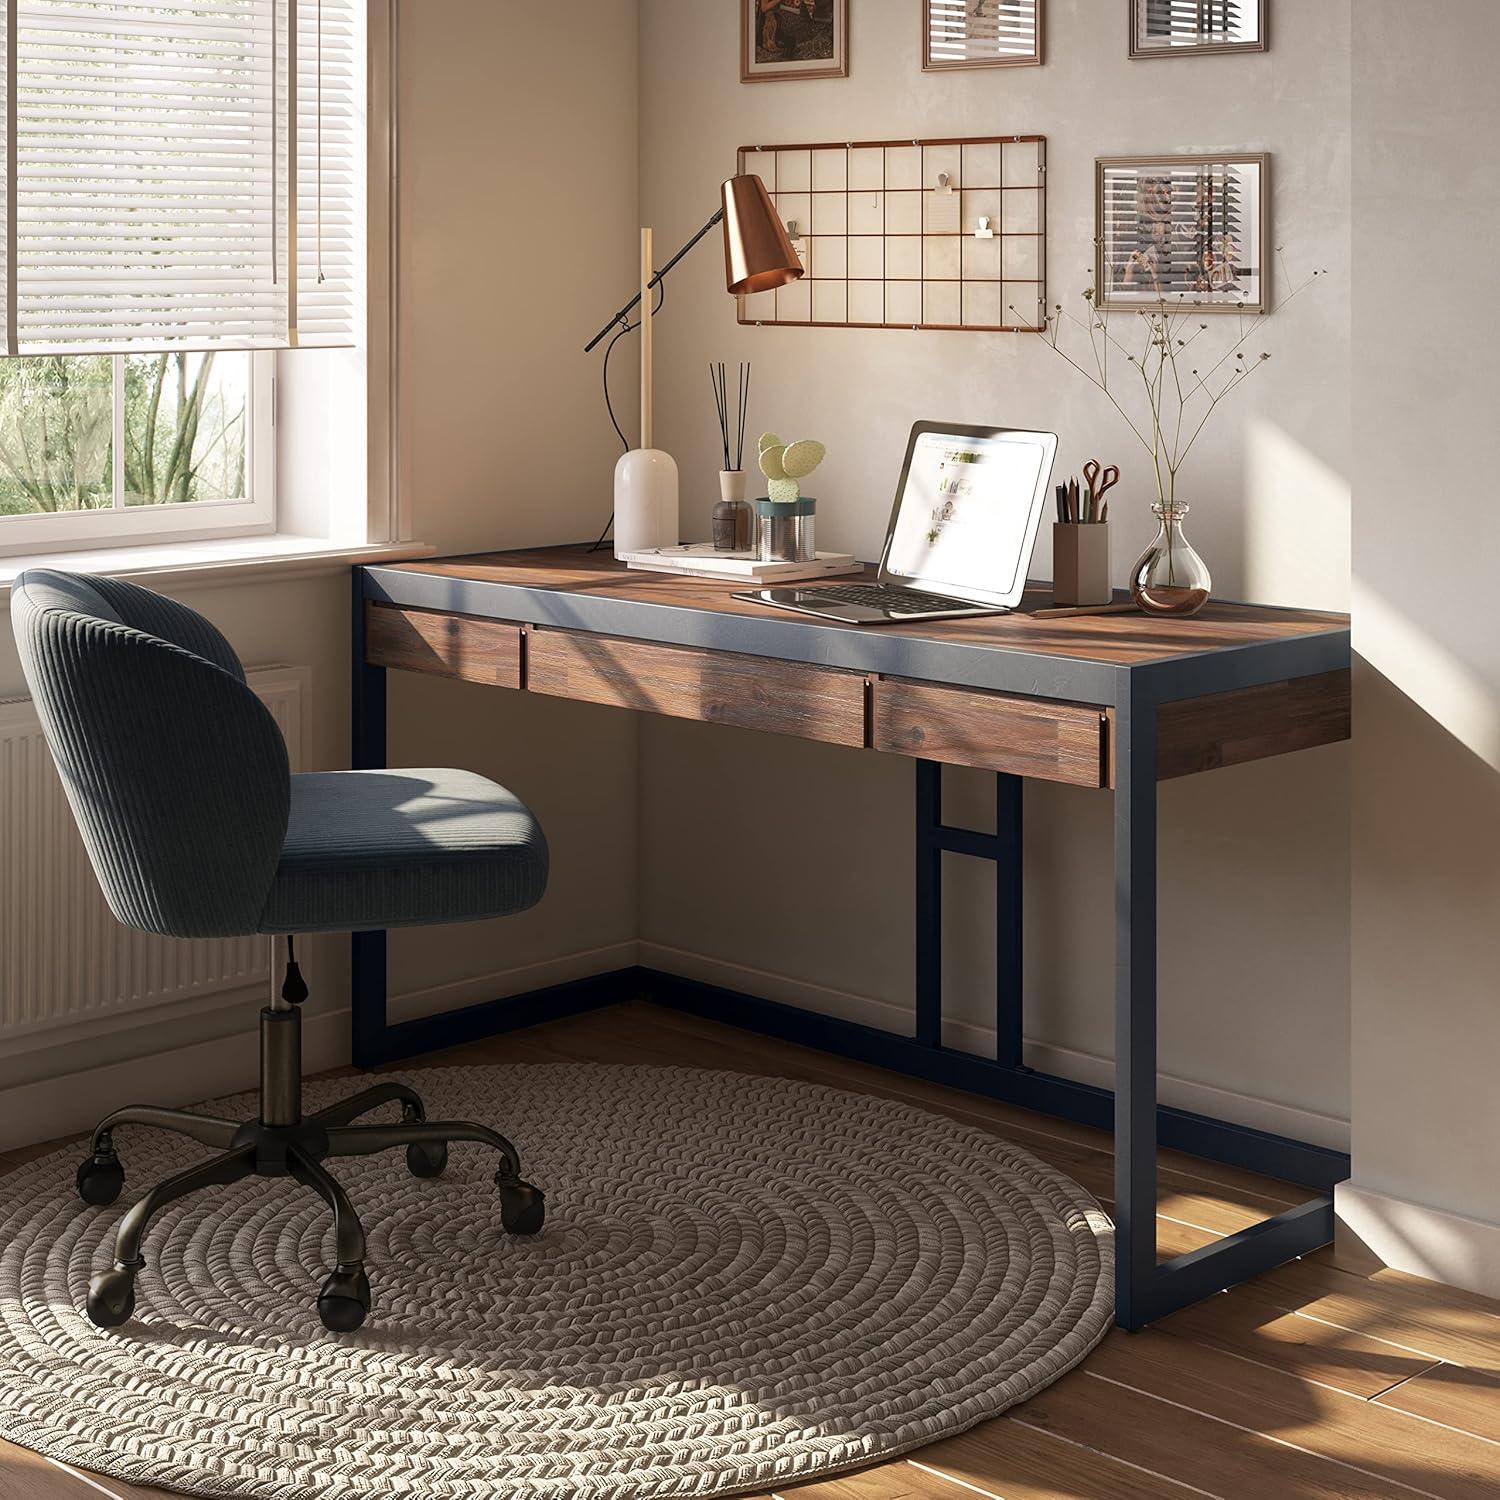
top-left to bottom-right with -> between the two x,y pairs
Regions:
527,630 -> 864,746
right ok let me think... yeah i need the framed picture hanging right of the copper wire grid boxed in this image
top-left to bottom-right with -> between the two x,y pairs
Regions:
1095,153 -> 1271,314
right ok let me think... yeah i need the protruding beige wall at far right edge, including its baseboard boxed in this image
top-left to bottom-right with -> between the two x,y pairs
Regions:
1341,0 -> 1500,1295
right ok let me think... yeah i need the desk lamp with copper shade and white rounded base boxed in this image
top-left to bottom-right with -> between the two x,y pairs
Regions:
584,173 -> 803,558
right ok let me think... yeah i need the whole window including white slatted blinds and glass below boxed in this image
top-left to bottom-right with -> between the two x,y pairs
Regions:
0,0 -> 365,552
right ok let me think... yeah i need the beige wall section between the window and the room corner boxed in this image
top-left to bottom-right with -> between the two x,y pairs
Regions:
390,0 -> 638,1011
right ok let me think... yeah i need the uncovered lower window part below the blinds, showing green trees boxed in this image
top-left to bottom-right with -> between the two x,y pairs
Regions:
0,351 -> 275,552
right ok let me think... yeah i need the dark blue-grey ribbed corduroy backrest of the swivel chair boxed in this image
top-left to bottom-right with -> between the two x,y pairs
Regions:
11,569 -> 291,938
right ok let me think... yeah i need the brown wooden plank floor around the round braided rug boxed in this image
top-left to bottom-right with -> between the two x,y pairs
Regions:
0,1005 -> 1500,1500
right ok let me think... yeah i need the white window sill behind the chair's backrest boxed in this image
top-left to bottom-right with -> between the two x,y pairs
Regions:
0,534 -> 435,605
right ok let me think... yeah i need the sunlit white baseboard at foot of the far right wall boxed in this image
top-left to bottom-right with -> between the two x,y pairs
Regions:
1334,1182 -> 1500,1298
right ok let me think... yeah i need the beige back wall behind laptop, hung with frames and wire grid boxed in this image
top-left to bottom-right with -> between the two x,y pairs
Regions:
627,0 -> 1350,1143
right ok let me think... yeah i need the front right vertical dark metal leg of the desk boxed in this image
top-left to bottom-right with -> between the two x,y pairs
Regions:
1115,683 -> 1157,1329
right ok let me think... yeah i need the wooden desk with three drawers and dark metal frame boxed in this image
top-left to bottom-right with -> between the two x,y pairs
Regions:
354,548 -> 1350,1328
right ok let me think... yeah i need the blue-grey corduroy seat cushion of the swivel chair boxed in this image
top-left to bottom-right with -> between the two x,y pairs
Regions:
261,770 -> 548,933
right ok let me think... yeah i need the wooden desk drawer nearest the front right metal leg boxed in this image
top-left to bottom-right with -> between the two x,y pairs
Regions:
870,677 -> 1107,786
